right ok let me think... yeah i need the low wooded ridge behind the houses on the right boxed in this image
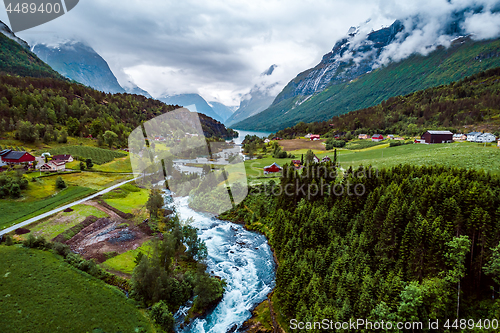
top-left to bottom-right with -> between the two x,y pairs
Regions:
276,68 -> 500,138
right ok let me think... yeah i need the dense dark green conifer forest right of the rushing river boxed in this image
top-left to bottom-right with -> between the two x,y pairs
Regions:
223,164 -> 500,332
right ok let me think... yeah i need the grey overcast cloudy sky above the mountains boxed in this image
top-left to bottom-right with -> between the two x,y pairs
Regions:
0,0 -> 500,105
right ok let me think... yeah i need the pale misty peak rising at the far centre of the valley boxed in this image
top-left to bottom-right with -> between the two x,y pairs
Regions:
226,65 -> 279,126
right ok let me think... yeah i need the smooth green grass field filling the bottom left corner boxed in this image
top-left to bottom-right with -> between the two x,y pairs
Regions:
0,246 -> 153,333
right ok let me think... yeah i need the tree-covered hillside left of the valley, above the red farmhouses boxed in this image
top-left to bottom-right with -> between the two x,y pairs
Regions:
0,75 -> 237,143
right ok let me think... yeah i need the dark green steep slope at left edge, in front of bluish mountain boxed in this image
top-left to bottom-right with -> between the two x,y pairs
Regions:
0,21 -> 64,79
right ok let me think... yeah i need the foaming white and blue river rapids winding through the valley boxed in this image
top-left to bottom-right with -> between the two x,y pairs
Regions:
174,197 -> 276,333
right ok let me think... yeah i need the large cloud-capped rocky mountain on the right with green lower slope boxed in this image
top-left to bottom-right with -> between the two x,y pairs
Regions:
236,3 -> 500,130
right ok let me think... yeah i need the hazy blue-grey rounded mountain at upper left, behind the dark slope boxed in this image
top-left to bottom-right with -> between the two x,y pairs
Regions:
33,41 -> 125,93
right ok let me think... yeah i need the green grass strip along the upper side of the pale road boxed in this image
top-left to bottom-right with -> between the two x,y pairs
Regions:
0,186 -> 94,229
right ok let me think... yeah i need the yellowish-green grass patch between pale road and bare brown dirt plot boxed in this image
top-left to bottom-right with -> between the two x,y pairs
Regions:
29,205 -> 108,240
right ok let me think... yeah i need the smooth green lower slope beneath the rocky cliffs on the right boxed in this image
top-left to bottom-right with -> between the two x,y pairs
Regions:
233,39 -> 500,131
